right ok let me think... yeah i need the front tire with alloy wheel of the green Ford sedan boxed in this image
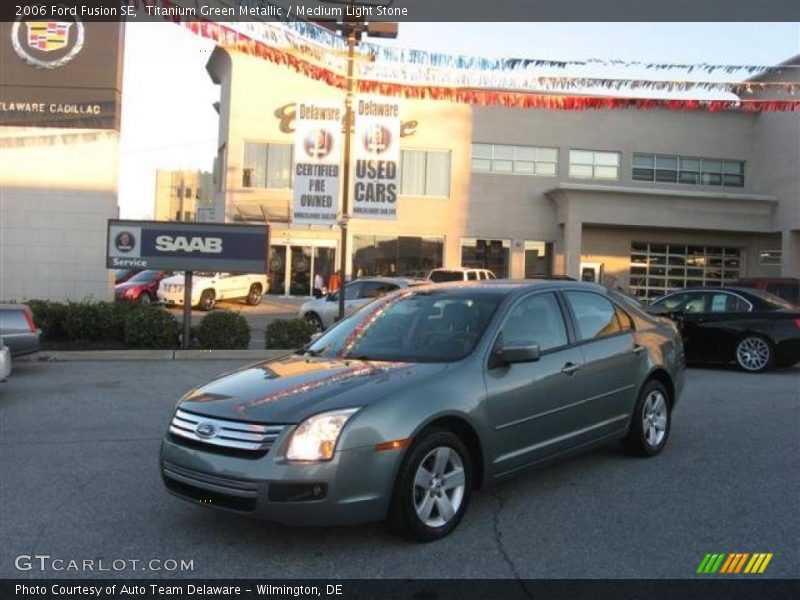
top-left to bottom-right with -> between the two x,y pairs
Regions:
388,429 -> 472,542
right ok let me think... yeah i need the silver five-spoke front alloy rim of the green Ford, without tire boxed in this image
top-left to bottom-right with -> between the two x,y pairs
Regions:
413,446 -> 466,527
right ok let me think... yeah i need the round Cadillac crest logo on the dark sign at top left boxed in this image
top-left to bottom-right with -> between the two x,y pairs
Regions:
11,19 -> 86,69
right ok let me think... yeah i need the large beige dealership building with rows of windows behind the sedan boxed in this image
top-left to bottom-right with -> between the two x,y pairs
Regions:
207,48 -> 800,297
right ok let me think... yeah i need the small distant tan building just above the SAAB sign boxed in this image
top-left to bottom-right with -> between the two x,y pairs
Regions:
153,169 -> 215,221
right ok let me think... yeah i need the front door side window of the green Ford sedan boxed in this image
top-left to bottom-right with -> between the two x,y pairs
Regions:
502,293 -> 567,352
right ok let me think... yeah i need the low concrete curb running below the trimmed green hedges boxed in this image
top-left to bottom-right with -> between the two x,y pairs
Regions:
24,350 -> 293,362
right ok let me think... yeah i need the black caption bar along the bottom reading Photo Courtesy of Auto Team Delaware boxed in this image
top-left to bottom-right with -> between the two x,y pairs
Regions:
0,575 -> 800,600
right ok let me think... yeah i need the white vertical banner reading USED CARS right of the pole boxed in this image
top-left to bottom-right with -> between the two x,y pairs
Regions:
353,97 -> 400,219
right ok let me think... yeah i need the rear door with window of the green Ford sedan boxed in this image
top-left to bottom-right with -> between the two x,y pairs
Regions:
564,290 -> 647,434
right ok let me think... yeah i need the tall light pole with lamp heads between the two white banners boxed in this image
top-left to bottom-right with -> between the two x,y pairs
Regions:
316,0 -> 397,319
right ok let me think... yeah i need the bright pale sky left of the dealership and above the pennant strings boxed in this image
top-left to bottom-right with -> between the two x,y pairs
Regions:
119,23 -> 800,219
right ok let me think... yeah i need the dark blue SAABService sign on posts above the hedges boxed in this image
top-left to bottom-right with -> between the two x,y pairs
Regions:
106,219 -> 269,273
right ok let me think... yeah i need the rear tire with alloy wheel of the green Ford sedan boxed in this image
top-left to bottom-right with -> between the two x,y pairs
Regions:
622,379 -> 672,457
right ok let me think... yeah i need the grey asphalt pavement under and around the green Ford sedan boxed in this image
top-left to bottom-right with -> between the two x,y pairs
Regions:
0,361 -> 800,578
